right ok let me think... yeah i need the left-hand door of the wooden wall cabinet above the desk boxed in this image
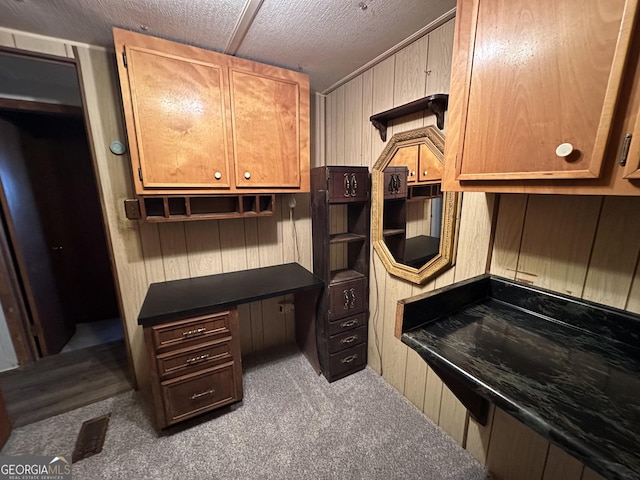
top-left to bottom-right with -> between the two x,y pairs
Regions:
125,46 -> 231,189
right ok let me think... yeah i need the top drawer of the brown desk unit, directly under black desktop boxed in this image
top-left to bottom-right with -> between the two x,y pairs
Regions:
152,311 -> 231,349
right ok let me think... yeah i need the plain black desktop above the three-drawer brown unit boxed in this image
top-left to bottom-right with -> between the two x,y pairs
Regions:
138,263 -> 324,327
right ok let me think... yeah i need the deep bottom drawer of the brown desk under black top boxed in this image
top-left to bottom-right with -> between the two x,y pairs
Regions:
162,362 -> 240,424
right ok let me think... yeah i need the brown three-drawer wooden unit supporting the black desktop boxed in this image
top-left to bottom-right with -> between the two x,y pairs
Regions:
144,309 -> 242,429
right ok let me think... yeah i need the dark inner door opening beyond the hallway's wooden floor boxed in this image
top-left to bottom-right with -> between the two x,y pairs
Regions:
0,108 -> 124,357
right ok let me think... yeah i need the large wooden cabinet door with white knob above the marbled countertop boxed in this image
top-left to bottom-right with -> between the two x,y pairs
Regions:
455,0 -> 638,180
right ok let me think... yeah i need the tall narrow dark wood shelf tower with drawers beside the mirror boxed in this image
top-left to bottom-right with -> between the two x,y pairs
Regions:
311,166 -> 370,382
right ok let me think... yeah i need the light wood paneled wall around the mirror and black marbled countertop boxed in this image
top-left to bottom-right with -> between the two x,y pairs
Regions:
325,17 -> 616,480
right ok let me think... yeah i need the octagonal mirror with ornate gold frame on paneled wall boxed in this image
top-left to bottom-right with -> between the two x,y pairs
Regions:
371,126 -> 462,284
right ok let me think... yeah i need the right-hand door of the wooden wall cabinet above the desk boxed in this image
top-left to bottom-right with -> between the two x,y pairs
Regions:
229,64 -> 308,188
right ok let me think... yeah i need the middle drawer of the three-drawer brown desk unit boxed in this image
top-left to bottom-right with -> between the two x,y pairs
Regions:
156,340 -> 233,379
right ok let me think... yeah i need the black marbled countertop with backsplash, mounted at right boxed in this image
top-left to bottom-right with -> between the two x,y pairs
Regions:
400,275 -> 640,479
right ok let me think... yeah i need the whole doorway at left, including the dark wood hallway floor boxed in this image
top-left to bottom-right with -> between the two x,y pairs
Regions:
0,47 -> 131,426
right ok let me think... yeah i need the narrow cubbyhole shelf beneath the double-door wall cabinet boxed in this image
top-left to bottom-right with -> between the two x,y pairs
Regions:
125,194 -> 276,222
